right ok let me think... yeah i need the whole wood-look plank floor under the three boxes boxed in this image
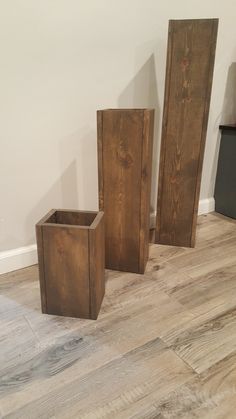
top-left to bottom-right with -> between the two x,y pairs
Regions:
0,213 -> 236,419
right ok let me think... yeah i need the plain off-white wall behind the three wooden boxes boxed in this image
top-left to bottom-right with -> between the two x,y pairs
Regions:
0,0 -> 236,252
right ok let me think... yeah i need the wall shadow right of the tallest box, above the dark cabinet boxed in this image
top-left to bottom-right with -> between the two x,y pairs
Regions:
209,63 -> 236,196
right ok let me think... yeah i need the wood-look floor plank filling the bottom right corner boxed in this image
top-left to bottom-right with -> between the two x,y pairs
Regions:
153,353 -> 236,419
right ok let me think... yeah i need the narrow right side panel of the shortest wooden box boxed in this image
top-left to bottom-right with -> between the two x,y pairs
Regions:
89,216 -> 105,320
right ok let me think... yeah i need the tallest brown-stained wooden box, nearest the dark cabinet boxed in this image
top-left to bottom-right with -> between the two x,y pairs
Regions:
156,19 -> 218,247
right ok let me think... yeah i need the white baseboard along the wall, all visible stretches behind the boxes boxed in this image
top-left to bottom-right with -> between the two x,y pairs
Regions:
0,198 -> 215,274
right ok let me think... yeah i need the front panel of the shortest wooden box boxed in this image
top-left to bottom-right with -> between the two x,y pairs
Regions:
42,225 -> 90,318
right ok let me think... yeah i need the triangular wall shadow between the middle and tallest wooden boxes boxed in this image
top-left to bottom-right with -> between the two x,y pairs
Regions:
118,54 -> 160,212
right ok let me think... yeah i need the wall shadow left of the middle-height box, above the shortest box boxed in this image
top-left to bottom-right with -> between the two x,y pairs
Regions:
25,126 -> 98,244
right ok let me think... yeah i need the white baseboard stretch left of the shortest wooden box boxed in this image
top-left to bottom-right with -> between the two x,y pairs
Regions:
0,244 -> 38,274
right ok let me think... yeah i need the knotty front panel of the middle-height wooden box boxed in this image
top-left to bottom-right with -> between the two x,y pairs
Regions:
98,110 -> 143,272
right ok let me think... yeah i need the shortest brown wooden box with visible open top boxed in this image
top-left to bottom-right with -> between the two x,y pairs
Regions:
36,210 -> 105,319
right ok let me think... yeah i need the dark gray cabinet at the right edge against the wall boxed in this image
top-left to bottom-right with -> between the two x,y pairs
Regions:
215,125 -> 236,218
